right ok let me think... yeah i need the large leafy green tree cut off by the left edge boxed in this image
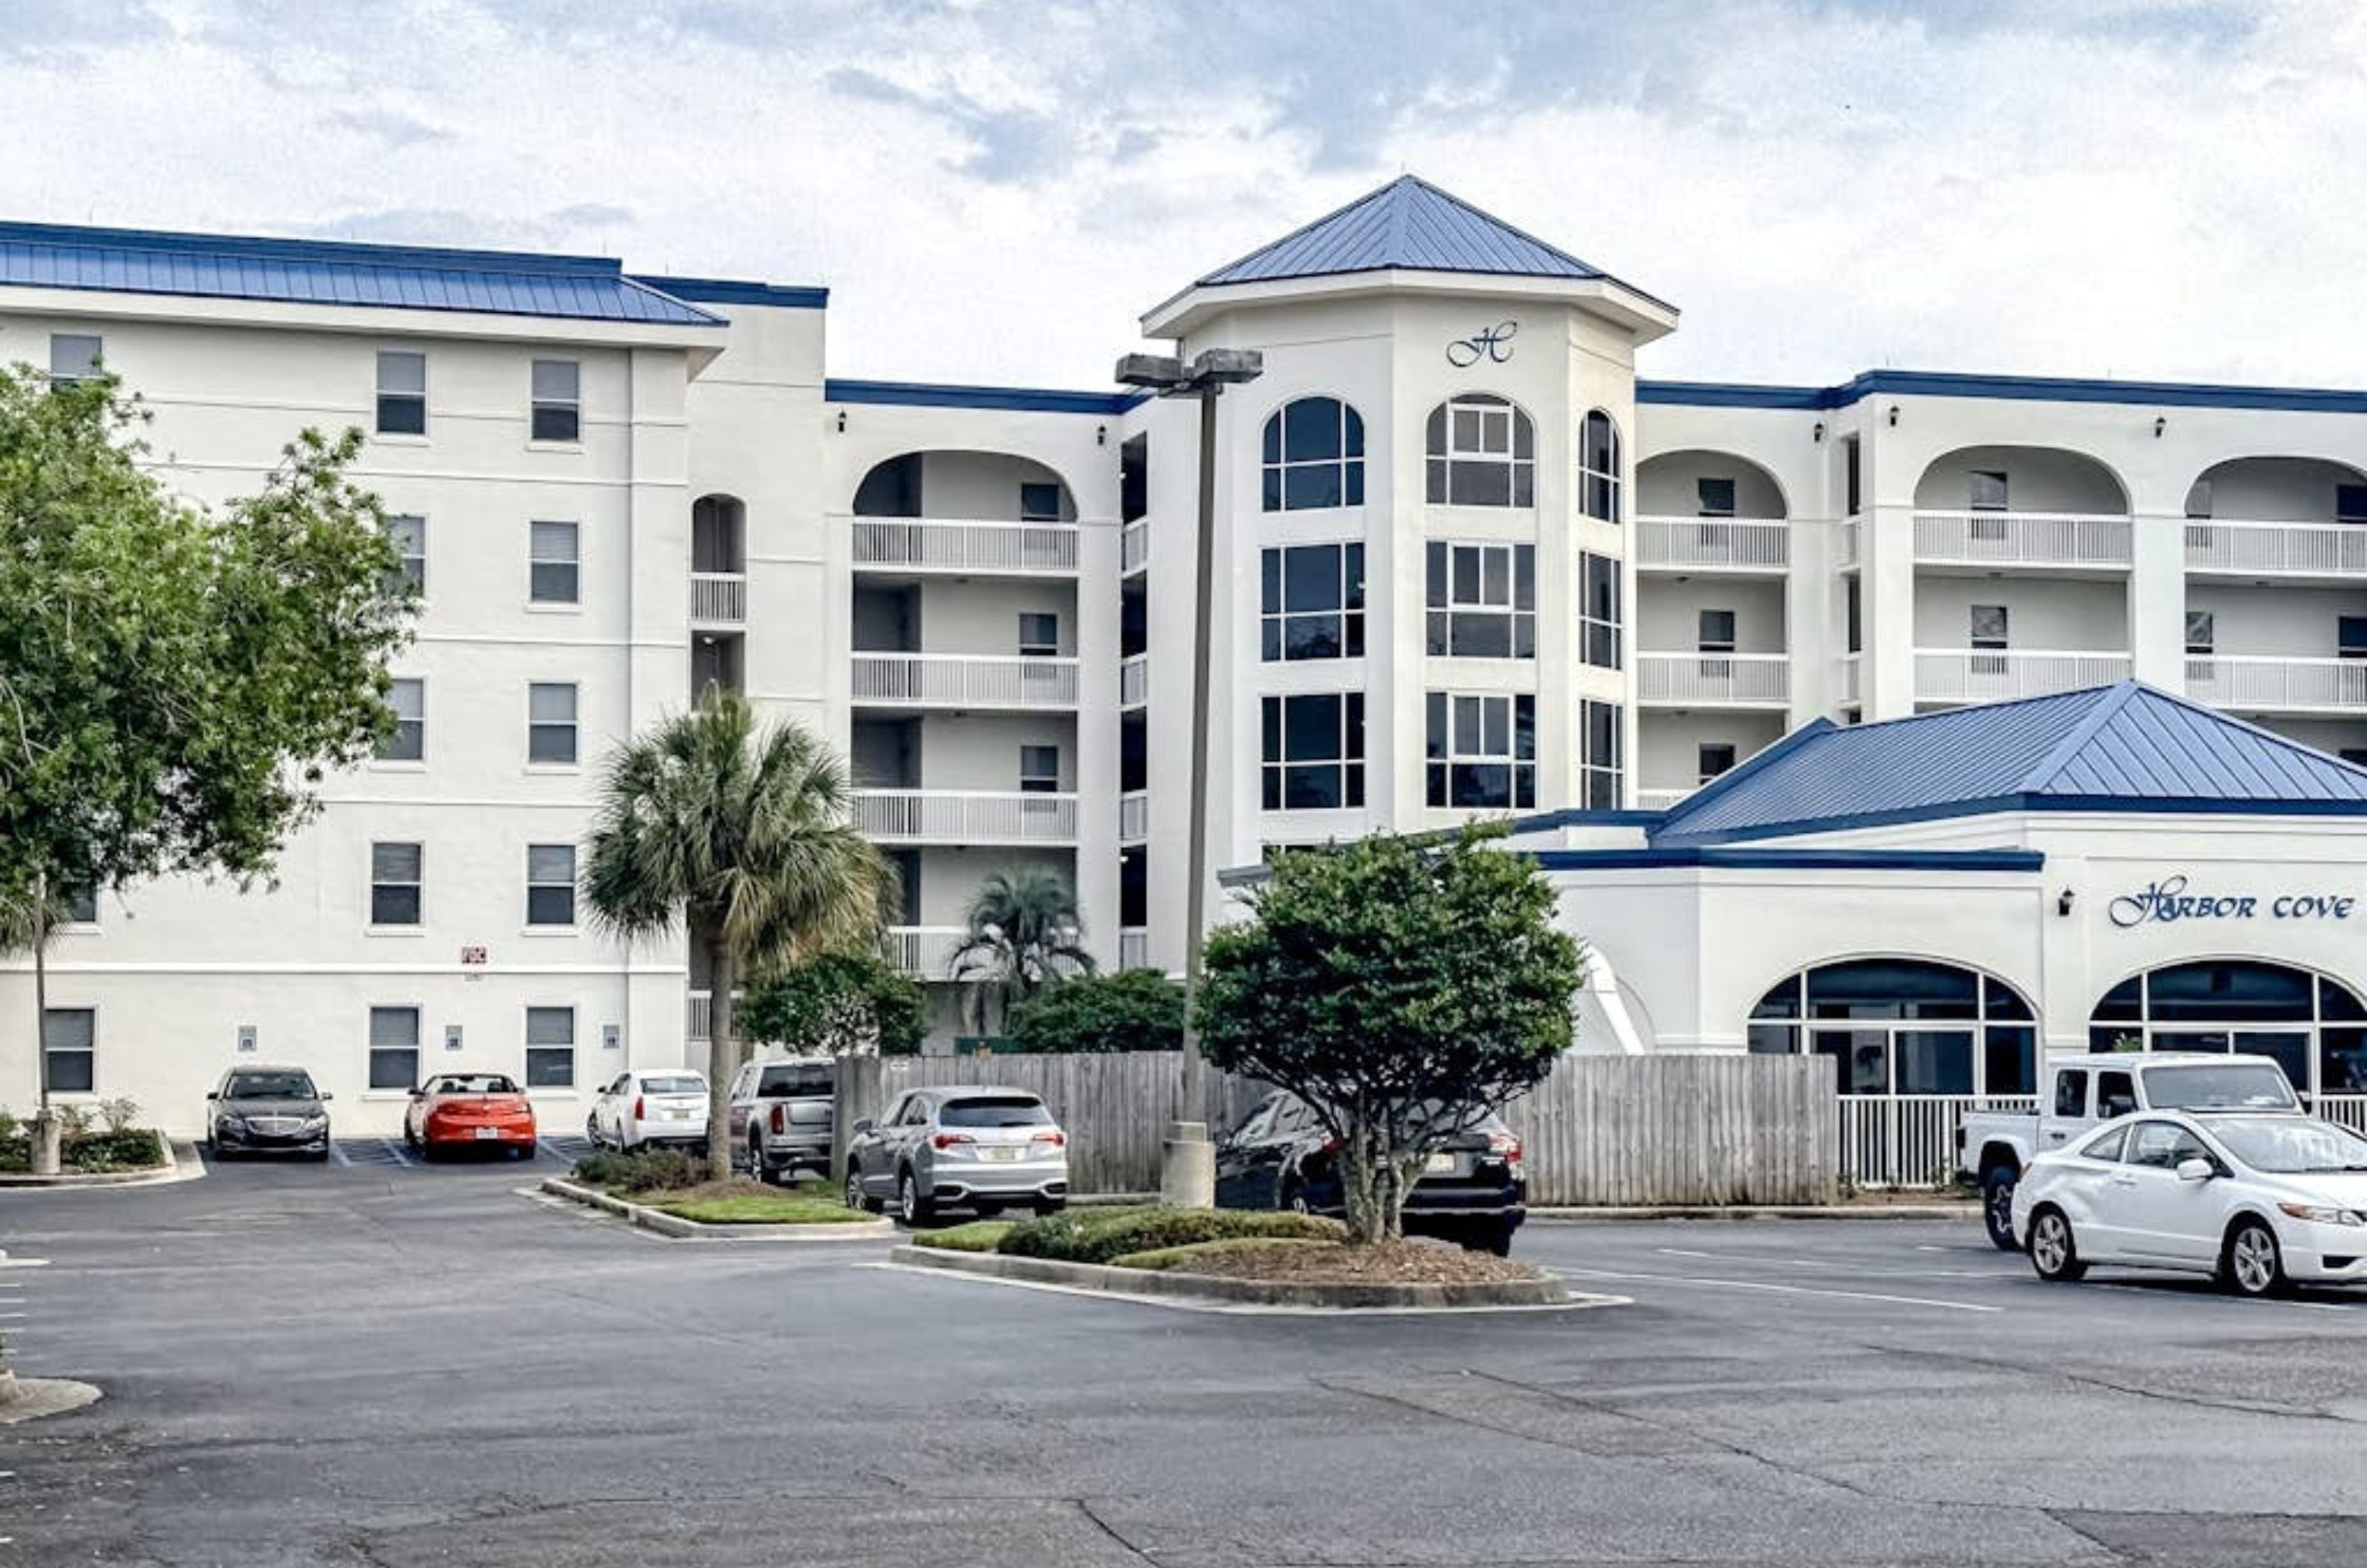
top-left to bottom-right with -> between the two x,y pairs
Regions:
0,365 -> 414,1132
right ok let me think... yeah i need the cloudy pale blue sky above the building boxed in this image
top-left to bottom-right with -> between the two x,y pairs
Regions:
0,0 -> 2367,386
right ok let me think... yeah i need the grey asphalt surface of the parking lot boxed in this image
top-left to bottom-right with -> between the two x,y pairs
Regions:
0,1156 -> 2367,1568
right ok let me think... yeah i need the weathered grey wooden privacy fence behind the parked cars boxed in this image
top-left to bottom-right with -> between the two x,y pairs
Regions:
838,1052 -> 1842,1206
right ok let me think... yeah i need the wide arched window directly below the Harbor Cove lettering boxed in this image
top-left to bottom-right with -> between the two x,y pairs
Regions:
2087,959 -> 2367,1095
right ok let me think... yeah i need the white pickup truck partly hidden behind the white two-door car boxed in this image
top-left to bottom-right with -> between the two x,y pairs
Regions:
1955,1052 -> 2300,1253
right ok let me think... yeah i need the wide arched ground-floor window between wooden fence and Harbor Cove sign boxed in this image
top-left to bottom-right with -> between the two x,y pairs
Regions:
1749,959 -> 2038,1095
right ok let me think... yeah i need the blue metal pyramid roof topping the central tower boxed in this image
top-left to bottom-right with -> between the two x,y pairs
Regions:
1200,175 -> 1641,294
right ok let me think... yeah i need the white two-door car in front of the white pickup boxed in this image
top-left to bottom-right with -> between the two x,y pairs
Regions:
2014,1111 -> 2367,1296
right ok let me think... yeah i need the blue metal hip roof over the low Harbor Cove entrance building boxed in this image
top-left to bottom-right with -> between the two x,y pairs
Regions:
1650,680 -> 2367,845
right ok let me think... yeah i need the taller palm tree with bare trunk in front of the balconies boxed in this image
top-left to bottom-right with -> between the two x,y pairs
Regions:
582,687 -> 895,1175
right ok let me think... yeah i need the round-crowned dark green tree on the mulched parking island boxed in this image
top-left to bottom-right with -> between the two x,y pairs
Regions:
1198,829 -> 1584,1241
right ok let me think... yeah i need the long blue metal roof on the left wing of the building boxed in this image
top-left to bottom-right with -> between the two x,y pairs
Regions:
0,223 -> 724,327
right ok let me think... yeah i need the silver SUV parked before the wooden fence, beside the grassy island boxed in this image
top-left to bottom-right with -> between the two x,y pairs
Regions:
848,1089 -> 1067,1225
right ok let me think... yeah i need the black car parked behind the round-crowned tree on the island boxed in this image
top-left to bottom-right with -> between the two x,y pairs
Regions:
1217,1095 -> 1529,1255
